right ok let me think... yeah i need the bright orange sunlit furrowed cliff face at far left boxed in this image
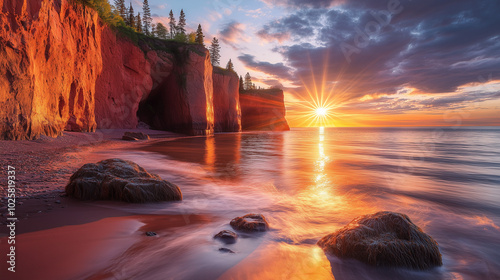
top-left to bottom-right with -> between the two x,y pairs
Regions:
0,0 -> 102,139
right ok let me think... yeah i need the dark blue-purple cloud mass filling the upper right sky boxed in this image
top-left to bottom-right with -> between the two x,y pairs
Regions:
254,0 -> 500,105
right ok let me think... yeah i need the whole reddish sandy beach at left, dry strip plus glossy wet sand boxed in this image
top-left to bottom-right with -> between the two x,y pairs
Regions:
0,129 -> 203,279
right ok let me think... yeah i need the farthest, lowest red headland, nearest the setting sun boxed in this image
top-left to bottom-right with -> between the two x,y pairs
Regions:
240,89 -> 290,131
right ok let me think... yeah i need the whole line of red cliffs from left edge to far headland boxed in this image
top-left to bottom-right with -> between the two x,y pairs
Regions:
0,0 -> 286,140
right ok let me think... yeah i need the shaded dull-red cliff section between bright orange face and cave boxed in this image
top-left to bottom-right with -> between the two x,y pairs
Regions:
95,28 -> 173,128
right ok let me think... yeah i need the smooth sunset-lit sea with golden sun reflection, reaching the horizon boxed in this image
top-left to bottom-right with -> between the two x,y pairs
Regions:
16,127 -> 500,280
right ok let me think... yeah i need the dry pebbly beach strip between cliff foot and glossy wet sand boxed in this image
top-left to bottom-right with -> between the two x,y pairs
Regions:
0,129 -> 187,234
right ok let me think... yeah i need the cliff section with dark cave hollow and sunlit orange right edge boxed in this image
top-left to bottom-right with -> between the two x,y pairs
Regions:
138,43 -> 214,135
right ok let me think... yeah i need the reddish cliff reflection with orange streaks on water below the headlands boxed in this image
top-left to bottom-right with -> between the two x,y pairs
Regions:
144,133 -> 283,180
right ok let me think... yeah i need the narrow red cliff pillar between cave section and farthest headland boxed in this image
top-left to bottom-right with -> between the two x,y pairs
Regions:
213,67 -> 241,132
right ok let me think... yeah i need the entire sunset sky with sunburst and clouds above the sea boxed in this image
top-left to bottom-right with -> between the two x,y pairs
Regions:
133,0 -> 500,126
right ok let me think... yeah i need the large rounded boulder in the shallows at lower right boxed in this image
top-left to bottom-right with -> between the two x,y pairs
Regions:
318,211 -> 443,269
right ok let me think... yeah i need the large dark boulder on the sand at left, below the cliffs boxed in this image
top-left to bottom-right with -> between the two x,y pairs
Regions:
66,159 -> 182,203
